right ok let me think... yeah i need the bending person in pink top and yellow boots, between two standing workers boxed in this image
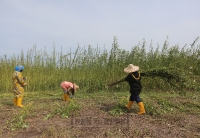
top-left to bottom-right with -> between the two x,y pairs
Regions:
60,81 -> 79,101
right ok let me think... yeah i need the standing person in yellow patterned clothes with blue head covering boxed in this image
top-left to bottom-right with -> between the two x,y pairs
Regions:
12,65 -> 27,107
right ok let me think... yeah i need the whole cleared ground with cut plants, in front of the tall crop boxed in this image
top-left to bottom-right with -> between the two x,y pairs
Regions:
0,90 -> 200,138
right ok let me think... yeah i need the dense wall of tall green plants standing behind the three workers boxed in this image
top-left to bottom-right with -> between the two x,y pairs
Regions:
0,37 -> 200,92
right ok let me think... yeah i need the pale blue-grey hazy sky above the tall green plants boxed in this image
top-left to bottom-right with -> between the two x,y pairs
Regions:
0,0 -> 200,56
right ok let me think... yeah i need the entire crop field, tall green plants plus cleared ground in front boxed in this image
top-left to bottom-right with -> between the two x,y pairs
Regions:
0,37 -> 200,138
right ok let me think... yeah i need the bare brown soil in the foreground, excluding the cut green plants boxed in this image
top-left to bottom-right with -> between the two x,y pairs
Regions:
0,91 -> 200,138
